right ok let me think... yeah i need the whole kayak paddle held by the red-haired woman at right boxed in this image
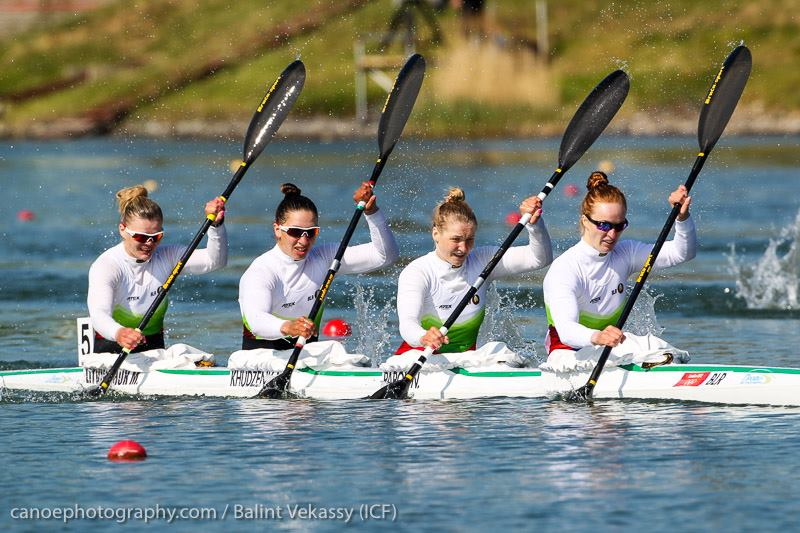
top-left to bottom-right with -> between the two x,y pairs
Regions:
567,45 -> 753,401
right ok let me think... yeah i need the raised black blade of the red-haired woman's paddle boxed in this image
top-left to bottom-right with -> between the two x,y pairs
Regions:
697,45 -> 753,152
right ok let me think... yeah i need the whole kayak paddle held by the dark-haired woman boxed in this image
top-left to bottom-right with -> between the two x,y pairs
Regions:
256,54 -> 425,398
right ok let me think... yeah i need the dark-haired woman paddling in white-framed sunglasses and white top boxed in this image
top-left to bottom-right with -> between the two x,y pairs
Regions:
239,182 -> 398,350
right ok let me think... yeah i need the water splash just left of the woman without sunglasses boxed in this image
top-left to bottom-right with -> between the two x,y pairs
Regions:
350,281 -> 395,366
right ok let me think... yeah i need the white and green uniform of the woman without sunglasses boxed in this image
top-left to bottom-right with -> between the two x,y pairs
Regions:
395,219 -> 553,354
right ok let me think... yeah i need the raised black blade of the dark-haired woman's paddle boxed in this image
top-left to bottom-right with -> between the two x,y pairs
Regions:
378,54 -> 425,159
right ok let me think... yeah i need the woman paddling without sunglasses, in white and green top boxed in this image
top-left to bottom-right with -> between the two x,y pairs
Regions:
395,187 -> 553,354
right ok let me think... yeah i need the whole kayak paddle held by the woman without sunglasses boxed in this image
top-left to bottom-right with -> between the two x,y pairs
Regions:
370,70 -> 630,400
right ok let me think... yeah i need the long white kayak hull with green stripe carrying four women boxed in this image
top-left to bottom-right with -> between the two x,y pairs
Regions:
0,364 -> 800,405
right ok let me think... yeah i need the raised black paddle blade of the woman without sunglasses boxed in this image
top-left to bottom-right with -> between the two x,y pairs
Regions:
558,70 -> 631,172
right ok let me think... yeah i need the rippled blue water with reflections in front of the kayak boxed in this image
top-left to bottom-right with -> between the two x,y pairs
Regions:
0,392 -> 800,531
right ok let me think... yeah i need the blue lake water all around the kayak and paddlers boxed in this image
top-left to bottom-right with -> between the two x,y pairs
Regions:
0,137 -> 800,531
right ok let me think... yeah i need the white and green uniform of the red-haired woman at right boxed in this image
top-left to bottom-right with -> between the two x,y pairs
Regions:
544,216 -> 697,354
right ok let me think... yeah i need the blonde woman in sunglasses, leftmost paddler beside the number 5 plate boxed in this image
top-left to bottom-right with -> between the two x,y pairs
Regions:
87,185 -> 228,353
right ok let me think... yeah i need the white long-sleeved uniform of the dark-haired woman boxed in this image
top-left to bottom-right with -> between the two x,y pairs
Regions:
239,211 -> 399,350
